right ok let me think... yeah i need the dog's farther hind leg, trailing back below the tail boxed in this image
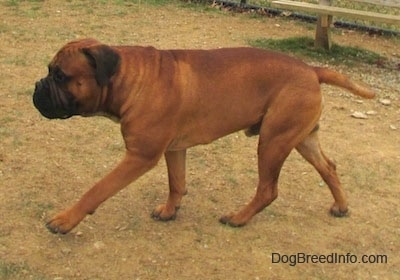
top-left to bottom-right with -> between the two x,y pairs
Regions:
296,130 -> 348,217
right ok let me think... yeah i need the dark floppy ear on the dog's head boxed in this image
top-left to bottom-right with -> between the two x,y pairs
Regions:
82,45 -> 121,87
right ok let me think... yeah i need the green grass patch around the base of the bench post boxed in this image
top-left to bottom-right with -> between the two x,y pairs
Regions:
249,37 -> 386,65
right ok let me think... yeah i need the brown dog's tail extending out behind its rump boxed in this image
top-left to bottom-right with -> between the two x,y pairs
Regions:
314,67 -> 375,99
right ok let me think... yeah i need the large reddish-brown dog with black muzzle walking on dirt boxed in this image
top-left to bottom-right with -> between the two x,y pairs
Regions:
33,39 -> 374,233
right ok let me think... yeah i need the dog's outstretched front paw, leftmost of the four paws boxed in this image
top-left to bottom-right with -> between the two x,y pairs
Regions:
46,210 -> 85,234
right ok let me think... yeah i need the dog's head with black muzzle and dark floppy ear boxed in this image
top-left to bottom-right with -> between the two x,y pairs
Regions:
33,39 -> 120,119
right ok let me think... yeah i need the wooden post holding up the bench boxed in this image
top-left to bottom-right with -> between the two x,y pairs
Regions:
314,0 -> 332,50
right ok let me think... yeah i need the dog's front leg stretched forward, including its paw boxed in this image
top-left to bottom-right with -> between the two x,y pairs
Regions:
46,152 -> 159,234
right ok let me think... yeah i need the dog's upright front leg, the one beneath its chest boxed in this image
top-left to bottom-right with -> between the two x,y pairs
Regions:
151,150 -> 186,221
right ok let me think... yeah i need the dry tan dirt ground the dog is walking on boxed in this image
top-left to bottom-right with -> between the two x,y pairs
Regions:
0,1 -> 400,280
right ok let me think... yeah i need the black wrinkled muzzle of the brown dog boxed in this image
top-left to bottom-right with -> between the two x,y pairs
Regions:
33,77 -> 77,119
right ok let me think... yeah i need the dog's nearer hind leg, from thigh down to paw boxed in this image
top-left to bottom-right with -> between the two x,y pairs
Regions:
220,94 -> 321,226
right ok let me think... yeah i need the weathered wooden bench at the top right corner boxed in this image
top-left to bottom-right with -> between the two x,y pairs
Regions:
271,0 -> 400,50
